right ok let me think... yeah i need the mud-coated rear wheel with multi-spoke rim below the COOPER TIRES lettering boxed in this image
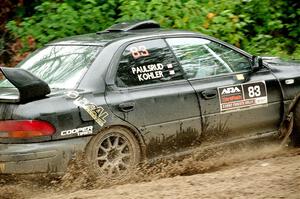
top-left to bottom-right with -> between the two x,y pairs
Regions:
86,127 -> 141,179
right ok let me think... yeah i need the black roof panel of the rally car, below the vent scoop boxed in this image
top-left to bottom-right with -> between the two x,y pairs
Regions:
48,28 -> 199,46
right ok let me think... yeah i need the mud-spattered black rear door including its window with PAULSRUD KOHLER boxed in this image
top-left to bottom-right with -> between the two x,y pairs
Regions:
106,39 -> 201,157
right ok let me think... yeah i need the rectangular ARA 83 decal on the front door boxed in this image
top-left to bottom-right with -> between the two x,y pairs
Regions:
218,82 -> 268,111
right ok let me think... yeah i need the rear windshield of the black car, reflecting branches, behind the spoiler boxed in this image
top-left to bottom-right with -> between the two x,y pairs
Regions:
0,45 -> 100,88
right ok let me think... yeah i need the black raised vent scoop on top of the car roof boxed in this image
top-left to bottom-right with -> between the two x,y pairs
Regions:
99,20 -> 160,32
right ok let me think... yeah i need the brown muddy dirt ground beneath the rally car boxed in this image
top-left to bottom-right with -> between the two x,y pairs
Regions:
0,144 -> 300,199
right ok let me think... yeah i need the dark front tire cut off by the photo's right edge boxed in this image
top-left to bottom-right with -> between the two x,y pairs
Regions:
290,102 -> 300,147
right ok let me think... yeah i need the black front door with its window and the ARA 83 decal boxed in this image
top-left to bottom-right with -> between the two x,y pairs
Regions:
167,38 -> 281,142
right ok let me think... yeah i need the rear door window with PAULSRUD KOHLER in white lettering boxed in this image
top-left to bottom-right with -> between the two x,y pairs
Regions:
116,39 -> 183,87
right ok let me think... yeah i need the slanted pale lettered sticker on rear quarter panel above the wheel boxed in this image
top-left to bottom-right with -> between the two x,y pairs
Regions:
67,91 -> 108,127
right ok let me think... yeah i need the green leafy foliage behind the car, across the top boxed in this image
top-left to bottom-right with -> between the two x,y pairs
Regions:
6,0 -> 300,58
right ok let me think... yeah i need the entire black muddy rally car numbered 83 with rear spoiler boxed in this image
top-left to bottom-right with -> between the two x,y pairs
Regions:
0,21 -> 300,176
